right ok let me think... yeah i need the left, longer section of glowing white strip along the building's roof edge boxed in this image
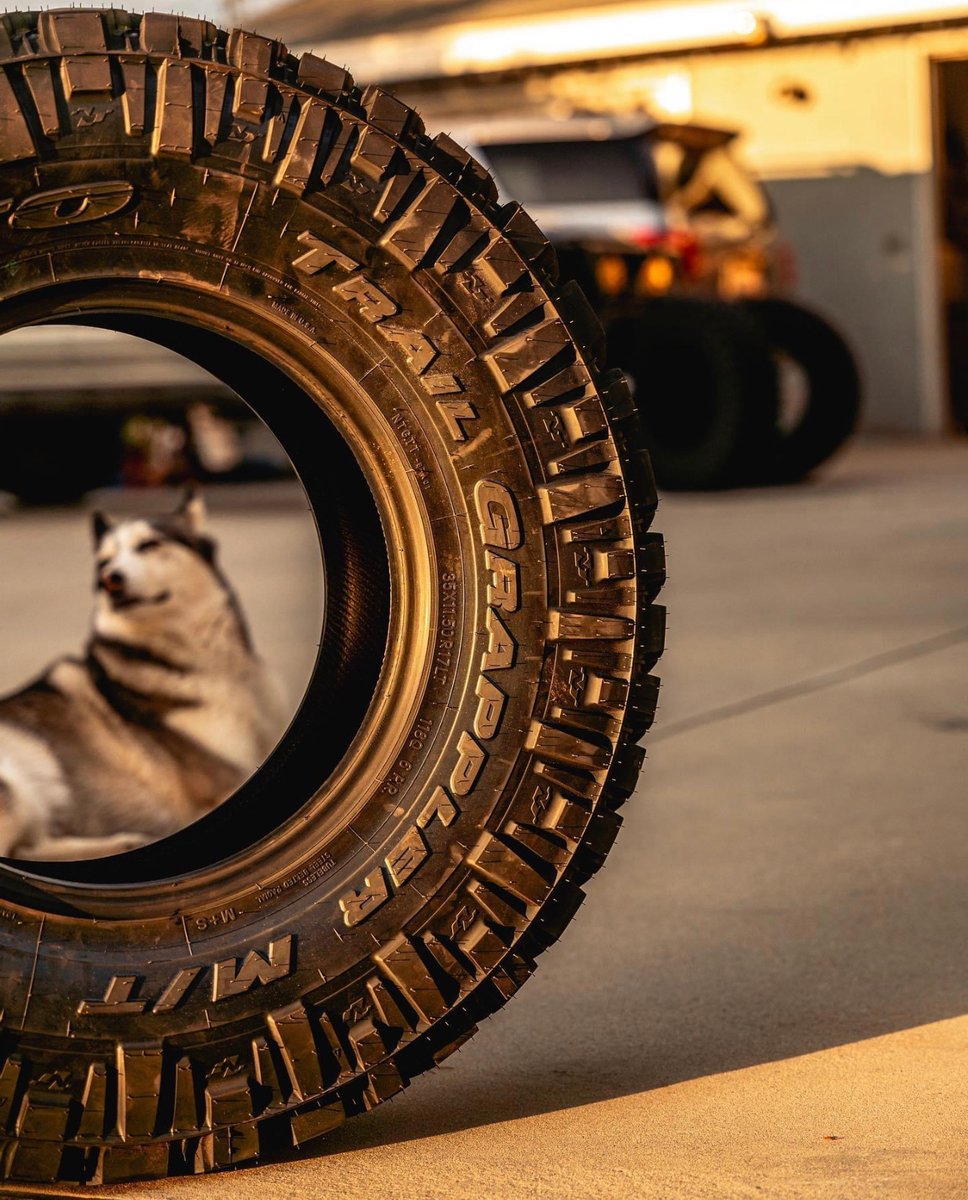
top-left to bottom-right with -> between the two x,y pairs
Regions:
443,4 -> 763,73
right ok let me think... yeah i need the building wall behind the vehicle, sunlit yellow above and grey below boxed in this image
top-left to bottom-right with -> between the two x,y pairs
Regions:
414,30 -> 968,432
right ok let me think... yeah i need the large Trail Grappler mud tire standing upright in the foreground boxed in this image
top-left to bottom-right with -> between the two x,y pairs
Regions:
0,8 -> 663,1182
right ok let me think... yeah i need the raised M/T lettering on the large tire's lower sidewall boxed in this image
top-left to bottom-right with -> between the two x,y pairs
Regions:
77,934 -> 296,1016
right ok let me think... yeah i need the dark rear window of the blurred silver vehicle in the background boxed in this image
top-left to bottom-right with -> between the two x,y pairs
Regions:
485,138 -> 659,205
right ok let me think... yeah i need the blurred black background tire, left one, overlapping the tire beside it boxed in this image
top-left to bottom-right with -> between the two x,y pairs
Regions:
609,296 -> 777,491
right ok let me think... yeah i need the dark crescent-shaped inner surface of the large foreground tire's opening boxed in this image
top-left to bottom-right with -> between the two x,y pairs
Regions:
0,311 -> 390,902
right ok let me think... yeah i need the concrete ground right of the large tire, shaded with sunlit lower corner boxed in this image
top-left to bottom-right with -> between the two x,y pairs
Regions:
1,443 -> 968,1200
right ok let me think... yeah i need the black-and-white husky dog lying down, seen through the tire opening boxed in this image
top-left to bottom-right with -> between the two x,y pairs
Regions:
0,492 -> 283,859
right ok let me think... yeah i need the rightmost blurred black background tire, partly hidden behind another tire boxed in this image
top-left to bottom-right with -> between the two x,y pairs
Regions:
744,299 -> 860,484
